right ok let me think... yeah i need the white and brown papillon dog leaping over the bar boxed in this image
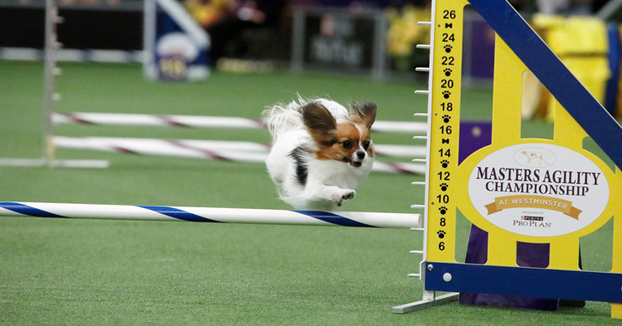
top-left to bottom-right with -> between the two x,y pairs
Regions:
263,98 -> 376,211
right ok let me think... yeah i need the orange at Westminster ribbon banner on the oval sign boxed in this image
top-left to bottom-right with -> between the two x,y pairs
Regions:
486,195 -> 583,220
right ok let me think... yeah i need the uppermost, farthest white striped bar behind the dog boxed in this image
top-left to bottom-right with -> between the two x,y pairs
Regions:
52,112 -> 428,134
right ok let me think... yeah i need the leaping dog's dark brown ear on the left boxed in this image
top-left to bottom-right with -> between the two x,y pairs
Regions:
300,102 -> 337,146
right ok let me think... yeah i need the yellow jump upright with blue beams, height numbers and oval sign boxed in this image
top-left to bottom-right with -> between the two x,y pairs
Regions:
404,0 -> 622,318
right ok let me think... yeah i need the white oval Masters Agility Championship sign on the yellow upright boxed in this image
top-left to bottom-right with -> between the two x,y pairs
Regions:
468,144 -> 609,237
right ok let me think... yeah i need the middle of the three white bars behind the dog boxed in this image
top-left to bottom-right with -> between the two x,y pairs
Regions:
54,136 -> 427,158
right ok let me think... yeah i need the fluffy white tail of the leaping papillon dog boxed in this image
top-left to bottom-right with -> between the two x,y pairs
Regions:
261,98 -> 306,143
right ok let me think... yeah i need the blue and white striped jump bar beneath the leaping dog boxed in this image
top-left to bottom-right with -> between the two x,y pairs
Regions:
0,202 -> 421,228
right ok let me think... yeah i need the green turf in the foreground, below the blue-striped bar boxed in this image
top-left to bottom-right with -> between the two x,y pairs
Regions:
0,218 -> 619,325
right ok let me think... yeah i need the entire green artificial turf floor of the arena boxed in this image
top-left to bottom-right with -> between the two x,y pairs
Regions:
0,62 -> 620,325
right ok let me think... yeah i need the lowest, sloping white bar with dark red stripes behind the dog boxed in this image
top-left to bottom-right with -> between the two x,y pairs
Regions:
53,136 -> 426,174
